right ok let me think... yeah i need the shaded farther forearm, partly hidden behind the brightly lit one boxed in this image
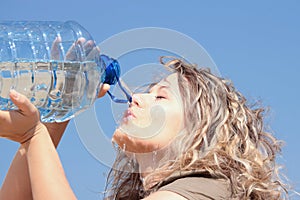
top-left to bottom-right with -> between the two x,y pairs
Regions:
0,121 -> 68,200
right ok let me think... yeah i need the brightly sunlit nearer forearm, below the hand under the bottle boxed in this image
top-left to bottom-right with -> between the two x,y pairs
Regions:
23,124 -> 76,200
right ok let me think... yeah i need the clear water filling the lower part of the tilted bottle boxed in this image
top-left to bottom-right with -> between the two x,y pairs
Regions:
0,61 -> 103,122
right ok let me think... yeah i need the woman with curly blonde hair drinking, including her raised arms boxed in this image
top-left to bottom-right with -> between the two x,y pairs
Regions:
0,55 -> 287,200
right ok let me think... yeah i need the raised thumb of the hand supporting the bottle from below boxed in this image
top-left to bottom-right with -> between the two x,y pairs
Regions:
9,90 -> 36,115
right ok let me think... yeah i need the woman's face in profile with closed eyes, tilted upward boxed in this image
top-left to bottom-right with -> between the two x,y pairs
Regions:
113,73 -> 184,153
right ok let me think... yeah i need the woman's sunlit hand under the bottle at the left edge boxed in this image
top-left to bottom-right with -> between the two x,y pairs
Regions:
0,90 -> 43,144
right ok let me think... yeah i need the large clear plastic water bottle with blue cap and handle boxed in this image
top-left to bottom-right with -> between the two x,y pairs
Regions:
0,21 -> 131,122
